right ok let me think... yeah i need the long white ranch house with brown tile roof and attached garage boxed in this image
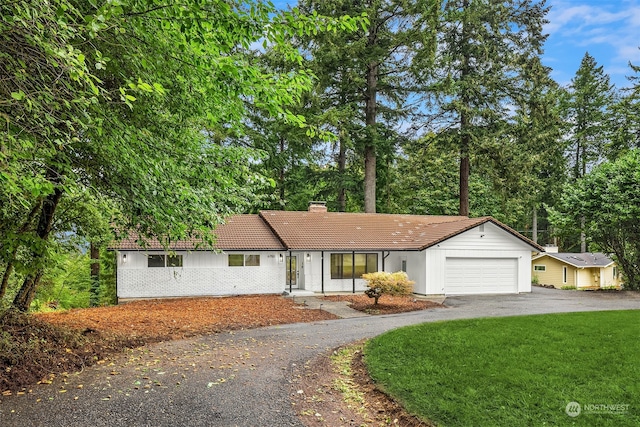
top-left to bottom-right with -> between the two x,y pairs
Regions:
111,204 -> 542,298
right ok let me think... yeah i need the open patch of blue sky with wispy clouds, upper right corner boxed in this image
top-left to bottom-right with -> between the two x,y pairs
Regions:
543,0 -> 640,88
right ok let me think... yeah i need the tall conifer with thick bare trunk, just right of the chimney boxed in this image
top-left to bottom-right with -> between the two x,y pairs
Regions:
300,0 -> 437,212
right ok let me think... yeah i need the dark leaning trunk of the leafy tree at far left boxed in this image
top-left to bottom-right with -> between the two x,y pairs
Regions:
13,187 -> 62,312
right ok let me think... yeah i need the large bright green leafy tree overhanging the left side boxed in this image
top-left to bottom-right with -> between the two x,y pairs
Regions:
0,0 -> 356,310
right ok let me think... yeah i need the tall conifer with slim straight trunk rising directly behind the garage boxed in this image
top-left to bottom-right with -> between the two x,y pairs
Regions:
416,0 -> 548,216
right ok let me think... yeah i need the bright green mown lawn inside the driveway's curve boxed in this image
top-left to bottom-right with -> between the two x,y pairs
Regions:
365,311 -> 640,426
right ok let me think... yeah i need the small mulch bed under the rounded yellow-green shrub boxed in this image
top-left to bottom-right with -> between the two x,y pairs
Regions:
325,294 -> 444,314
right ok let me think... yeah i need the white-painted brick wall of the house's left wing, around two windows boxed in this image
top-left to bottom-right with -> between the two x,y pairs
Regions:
117,251 -> 285,298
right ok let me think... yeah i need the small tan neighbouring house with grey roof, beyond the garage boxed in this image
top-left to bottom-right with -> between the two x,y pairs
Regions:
531,248 -> 622,289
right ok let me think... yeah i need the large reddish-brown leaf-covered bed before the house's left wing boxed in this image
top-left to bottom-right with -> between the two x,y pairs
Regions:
0,295 -> 337,395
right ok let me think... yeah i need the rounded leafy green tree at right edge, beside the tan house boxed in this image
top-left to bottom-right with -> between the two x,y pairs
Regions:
552,149 -> 640,290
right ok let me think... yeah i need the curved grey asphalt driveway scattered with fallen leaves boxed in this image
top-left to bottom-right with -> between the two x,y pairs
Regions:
0,288 -> 640,427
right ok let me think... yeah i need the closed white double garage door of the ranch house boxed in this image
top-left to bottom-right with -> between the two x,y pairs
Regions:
444,258 -> 518,295
